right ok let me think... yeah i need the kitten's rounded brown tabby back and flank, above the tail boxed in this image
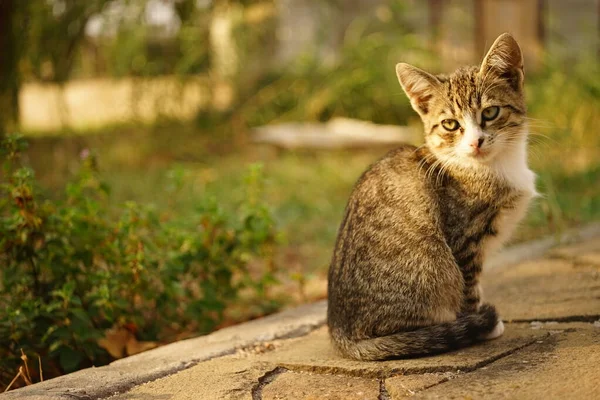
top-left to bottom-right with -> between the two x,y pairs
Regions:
328,145 -> 460,337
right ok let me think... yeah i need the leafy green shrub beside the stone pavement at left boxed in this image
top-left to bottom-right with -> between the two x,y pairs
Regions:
0,135 -> 276,384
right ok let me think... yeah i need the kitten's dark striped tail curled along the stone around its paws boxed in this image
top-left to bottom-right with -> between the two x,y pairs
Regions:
332,304 -> 504,361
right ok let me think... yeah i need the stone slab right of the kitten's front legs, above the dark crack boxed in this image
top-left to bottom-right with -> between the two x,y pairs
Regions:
482,259 -> 600,321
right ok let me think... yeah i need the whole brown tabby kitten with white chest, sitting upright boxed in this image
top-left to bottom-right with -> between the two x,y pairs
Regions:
328,33 -> 536,360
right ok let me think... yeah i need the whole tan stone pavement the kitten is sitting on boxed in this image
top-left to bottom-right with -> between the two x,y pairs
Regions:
0,233 -> 600,400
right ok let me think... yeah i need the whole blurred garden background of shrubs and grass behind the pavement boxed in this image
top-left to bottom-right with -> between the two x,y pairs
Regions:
0,0 -> 600,387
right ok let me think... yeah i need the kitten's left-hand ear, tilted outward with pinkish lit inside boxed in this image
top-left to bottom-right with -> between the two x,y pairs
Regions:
396,63 -> 440,115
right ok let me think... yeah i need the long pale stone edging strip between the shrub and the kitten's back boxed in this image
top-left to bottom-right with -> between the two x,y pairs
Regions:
0,301 -> 327,400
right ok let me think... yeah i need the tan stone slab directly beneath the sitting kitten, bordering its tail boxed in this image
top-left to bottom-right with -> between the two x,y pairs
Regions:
257,324 -> 548,378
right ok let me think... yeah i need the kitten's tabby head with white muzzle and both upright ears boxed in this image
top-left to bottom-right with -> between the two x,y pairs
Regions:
396,33 -> 527,164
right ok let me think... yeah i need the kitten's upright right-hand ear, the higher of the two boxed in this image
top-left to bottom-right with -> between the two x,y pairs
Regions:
479,33 -> 524,91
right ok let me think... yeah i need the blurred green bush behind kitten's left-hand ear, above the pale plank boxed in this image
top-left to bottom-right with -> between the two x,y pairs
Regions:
234,1 -> 428,127
